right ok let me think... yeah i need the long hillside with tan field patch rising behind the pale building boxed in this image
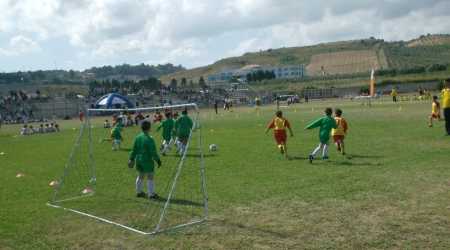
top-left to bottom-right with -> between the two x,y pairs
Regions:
161,35 -> 450,83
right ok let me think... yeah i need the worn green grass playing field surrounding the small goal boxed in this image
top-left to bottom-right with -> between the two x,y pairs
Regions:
0,98 -> 450,249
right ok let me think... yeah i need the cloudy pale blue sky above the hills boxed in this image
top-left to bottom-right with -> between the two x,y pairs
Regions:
0,0 -> 450,72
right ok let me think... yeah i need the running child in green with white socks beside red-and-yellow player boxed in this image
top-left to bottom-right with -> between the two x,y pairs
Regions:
305,108 -> 337,163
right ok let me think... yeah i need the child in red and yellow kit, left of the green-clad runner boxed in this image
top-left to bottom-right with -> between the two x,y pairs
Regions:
266,111 -> 294,158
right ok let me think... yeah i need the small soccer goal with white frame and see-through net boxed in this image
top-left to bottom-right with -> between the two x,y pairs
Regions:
47,103 -> 208,235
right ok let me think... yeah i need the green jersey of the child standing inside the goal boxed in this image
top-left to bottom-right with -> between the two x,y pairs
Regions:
130,132 -> 160,173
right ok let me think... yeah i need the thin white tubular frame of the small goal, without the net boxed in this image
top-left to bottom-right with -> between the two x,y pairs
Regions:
47,103 -> 208,235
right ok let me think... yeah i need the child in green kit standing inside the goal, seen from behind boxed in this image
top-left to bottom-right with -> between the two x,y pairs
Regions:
128,120 -> 161,199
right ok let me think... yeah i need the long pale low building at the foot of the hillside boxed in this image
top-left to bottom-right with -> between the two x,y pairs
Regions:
207,64 -> 306,85
